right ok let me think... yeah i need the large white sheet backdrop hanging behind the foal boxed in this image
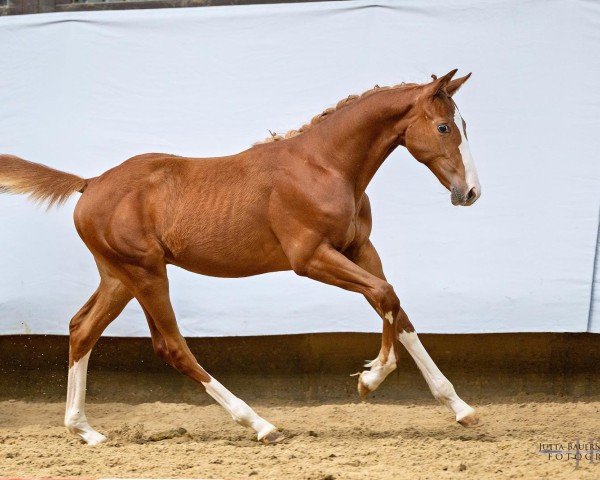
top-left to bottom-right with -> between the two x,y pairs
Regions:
0,0 -> 600,336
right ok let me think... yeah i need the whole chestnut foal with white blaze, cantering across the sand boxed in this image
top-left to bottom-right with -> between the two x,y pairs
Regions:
0,70 -> 481,445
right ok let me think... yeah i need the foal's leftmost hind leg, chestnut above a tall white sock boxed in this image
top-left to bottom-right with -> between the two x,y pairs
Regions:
65,273 -> 133,445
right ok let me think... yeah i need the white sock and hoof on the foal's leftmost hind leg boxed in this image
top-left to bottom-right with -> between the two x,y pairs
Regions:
65,350 -> 106,445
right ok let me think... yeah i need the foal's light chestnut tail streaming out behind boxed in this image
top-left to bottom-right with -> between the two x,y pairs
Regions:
0,155 -> 87,208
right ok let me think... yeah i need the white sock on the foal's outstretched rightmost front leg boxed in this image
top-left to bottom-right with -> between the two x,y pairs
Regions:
399,332 -> 475,422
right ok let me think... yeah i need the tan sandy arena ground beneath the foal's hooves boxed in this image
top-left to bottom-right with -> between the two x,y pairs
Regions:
0,397 -> 600,480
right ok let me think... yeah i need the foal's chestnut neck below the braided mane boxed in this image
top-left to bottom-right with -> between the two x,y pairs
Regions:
306,89 -> 414,199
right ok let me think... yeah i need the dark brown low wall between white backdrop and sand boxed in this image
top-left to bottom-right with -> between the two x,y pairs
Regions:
0,333 -> 600,404
